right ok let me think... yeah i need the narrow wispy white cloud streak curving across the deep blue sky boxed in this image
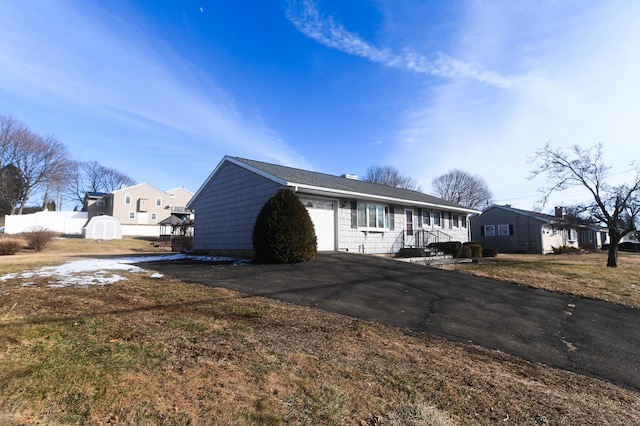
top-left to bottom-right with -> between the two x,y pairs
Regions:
286,0 -> 525,88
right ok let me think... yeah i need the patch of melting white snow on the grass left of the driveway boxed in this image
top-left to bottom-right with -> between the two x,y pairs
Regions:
0,254 -> 240,287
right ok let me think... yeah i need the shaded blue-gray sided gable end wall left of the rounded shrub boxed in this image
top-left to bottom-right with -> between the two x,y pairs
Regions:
192,162 -> 282,255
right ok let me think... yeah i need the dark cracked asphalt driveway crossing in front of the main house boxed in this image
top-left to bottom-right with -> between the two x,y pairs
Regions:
144,253 -> 640,392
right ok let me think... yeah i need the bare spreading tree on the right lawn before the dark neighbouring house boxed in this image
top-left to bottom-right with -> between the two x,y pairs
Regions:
530,144 -> 640,267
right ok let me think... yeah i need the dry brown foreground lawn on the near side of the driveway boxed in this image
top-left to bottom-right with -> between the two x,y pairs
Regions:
0,241 -> 640,425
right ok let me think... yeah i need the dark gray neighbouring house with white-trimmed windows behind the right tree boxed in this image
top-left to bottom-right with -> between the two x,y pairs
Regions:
470,205 -> 608,254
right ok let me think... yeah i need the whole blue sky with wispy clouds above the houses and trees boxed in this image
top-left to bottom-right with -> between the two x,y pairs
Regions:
0,0 -> 640,211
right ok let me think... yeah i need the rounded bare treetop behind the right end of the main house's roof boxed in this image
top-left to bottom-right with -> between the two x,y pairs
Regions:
431,169 -> 493,209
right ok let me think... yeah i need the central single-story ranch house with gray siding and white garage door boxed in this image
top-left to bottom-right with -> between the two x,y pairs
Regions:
187,156 -> 479,256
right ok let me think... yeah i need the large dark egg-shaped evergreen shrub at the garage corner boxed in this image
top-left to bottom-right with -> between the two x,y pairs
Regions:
253,189 -> 318,263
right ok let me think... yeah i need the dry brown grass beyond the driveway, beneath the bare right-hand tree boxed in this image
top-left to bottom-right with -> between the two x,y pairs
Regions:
442,252 -> 640,308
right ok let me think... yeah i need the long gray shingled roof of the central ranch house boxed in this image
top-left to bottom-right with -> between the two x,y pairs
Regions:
223,157 -> 480,213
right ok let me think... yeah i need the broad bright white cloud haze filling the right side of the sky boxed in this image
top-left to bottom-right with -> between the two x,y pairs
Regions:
393,0 -> 640,208
